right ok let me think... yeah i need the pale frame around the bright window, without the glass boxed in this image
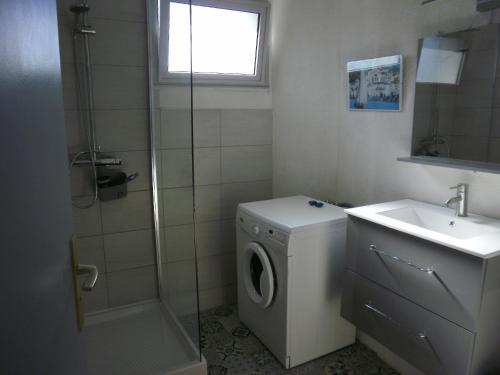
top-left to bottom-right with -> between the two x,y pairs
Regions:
158,0 -> 270,87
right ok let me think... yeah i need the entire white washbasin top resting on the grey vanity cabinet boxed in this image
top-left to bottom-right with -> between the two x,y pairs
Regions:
345,199 -> 500,258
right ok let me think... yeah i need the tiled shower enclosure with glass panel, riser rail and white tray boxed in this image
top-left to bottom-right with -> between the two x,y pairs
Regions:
59,0 -> 206,375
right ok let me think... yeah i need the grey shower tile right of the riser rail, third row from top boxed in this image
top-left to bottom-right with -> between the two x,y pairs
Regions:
92,65 -> 148,109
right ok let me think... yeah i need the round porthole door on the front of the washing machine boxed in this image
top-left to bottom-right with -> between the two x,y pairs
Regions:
243,242 -> 275,309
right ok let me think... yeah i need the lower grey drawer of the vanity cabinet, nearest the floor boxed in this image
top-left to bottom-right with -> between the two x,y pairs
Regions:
342,271 -> 474,375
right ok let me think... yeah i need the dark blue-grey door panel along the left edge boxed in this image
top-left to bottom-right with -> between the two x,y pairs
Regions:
0,0 -> 85,375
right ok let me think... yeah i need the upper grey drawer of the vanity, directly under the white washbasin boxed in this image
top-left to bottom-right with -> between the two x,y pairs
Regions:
346,217 -> 482,331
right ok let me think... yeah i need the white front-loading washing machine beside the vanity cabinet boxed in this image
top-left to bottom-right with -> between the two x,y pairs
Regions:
236,196 -> 355,368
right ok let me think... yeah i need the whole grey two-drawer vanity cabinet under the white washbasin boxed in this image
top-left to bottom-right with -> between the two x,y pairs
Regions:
342,216 -> 500,375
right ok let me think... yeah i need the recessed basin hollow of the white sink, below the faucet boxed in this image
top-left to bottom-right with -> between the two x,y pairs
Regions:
377,206 -> 500,240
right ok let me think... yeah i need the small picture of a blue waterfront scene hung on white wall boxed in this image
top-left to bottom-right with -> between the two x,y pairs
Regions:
347,55 -> 403,111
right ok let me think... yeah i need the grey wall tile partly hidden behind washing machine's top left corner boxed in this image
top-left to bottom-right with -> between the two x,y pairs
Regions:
222,180 -> 272,219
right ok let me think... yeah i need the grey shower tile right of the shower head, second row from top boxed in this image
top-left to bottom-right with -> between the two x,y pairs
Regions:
90,18 -> 148,66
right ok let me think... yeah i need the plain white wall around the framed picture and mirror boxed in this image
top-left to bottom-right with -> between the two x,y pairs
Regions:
272,0 -> 500,217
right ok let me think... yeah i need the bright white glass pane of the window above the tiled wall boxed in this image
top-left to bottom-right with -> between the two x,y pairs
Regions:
168,2 -> 259,75
